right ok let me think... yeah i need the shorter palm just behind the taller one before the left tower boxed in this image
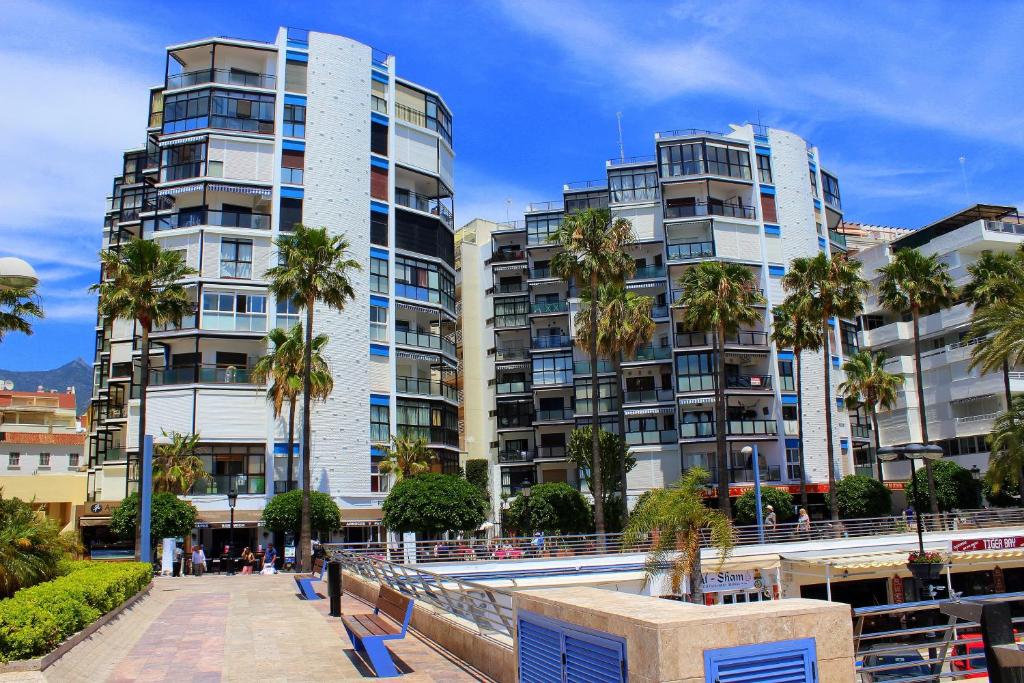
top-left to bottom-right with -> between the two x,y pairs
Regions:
252,323 -> 334,490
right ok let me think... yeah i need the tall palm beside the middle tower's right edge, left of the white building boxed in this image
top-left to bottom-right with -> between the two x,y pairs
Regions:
782,253 -> 867,519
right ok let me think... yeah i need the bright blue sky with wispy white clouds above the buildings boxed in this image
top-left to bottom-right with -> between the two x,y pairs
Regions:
0,0 -> 1024,370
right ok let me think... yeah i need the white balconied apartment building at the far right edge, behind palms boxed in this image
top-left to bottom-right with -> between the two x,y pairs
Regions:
856,205 -> 1024,479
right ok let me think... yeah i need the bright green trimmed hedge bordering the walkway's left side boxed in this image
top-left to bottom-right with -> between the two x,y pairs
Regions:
0,561 -> 153,661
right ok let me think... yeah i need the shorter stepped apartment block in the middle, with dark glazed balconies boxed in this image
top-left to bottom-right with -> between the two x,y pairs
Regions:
462,125 -> 857,520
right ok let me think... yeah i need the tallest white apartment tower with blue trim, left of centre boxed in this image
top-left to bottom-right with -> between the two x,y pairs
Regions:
88,29 -> 458,548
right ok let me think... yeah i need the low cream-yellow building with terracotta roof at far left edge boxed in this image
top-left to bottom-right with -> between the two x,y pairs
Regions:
0,387 -> 86,527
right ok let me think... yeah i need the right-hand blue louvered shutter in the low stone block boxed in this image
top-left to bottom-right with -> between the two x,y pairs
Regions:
705,638 -> 818,683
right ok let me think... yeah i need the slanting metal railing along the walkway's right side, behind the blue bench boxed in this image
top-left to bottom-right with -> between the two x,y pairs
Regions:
324,543 -> 514,648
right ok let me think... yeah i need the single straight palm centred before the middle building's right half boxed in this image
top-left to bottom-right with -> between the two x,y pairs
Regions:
677,261 -> 765,516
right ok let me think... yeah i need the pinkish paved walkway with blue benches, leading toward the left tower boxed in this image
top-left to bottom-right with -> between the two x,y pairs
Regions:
0,574 -> 485,683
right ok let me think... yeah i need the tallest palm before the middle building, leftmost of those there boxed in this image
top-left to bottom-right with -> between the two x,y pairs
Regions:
548,209 -> 636,543
